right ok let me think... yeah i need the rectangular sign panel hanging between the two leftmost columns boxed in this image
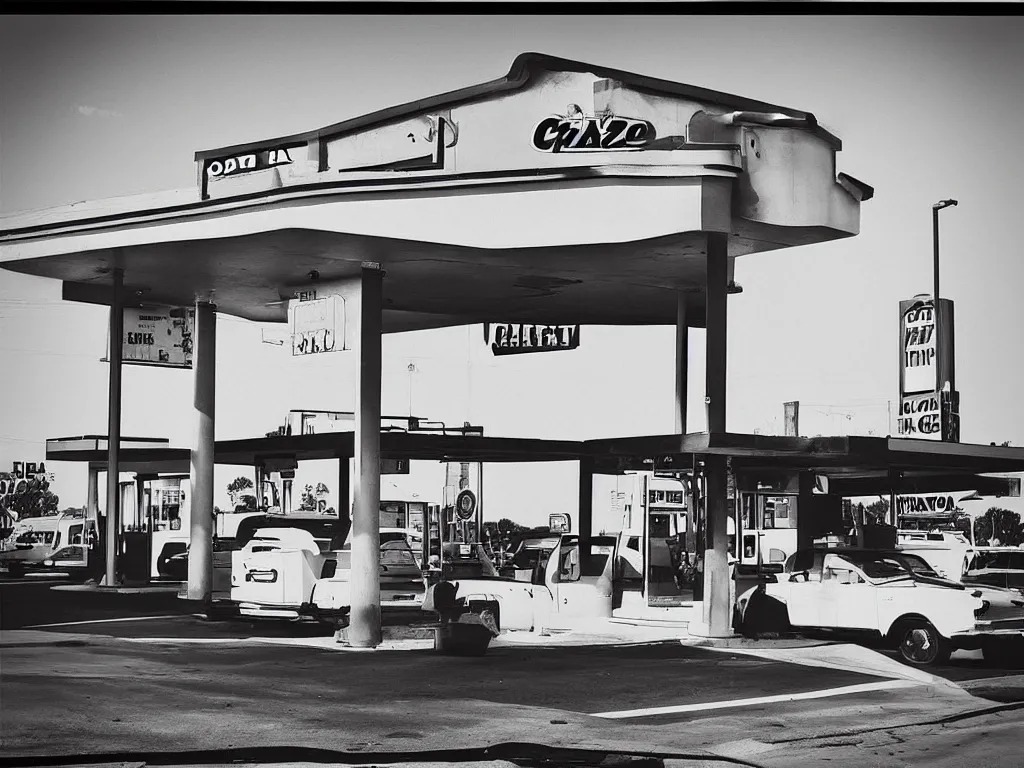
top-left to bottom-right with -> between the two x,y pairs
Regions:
115,306 -> 196,368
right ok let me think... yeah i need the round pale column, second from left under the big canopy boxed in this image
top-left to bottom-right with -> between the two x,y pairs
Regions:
187,302 -> 217,601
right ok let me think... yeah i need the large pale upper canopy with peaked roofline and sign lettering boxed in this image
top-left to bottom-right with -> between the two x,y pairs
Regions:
0,53 -> 872,332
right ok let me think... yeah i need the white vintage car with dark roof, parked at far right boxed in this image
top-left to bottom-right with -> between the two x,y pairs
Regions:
734,548 -> 1024,665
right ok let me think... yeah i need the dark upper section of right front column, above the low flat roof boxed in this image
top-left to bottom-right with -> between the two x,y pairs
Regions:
705,232 -> 729,436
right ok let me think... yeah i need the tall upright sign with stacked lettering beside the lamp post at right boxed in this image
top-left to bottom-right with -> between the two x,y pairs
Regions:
897,295 -> 959,442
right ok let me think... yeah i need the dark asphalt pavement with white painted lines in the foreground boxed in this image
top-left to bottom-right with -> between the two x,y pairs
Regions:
0,580 -> 1024,765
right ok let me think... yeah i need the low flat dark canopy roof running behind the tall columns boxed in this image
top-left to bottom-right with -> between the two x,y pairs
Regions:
46,431 -> 1024,497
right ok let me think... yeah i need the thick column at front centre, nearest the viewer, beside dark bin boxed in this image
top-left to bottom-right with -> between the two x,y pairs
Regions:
348,266 -> 383,648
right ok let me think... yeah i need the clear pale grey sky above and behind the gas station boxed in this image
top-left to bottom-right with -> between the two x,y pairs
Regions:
0,14 -> 1024,524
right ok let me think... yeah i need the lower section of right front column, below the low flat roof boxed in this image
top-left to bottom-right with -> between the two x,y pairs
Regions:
701,454 -> 732,637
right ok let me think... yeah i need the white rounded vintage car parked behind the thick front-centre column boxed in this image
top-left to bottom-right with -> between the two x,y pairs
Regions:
231,527 -> 425,627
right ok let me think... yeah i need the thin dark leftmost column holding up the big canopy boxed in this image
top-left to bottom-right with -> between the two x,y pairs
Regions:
103,269 -> 125,587
